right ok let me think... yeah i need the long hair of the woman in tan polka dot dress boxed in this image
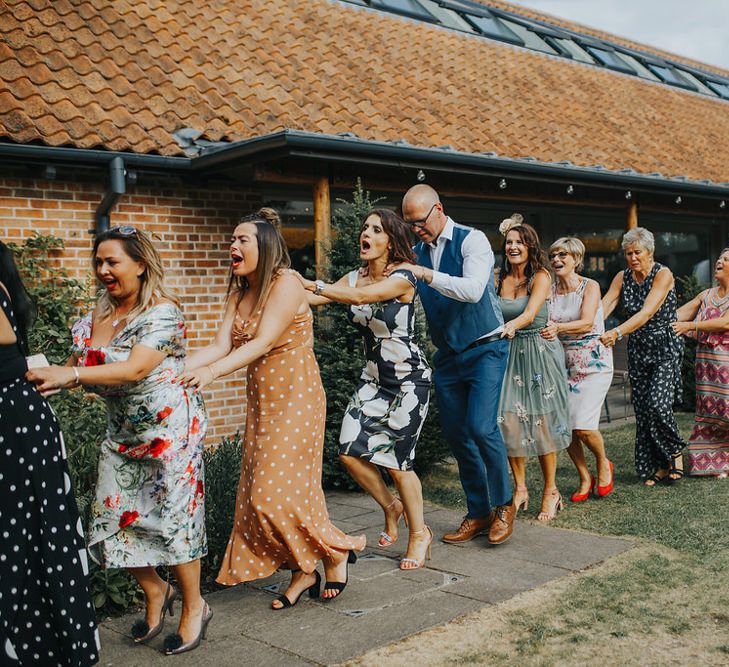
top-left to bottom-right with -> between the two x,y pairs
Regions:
228,207 -> 291,314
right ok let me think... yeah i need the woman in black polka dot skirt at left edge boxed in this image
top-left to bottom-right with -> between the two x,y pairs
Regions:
0,241 -> 98,666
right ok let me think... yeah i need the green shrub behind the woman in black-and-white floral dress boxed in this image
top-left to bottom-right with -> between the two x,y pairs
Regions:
314,182 -> 448,489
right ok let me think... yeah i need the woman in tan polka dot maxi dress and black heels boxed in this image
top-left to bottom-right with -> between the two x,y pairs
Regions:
183,209 -> 365,609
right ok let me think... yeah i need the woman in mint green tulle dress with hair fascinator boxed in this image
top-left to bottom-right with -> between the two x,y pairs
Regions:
497,214 -> 571,521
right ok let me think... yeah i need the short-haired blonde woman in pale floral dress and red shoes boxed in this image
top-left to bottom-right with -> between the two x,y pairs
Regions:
542,237 -> 613,503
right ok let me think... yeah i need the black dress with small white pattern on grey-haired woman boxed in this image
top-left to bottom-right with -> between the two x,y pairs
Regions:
622,263 -> 686,479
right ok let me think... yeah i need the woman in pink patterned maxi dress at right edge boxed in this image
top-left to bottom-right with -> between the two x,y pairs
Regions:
673,248 -> 729,479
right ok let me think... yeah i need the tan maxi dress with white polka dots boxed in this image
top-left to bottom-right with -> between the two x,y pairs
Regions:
217,310 -> 365,585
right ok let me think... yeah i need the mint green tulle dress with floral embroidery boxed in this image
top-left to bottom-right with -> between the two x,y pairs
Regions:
497,296 -> 572,457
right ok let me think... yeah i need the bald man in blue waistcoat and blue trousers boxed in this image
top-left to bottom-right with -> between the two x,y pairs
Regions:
402,184 -> 516,544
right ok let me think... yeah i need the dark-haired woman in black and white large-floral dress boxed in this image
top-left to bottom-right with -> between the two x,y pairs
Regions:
300,209 -> 433,570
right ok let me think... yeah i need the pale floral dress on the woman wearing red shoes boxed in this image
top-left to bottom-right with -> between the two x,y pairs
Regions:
549,278 -> 613,431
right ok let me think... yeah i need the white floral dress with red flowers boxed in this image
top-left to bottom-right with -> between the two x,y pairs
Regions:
72,303 -> 207,567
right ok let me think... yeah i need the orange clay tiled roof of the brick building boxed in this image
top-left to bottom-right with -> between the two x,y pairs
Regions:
0,0 -> 729,182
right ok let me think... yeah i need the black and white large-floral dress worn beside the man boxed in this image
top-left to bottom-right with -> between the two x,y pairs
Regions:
339,270 -> 431,470
